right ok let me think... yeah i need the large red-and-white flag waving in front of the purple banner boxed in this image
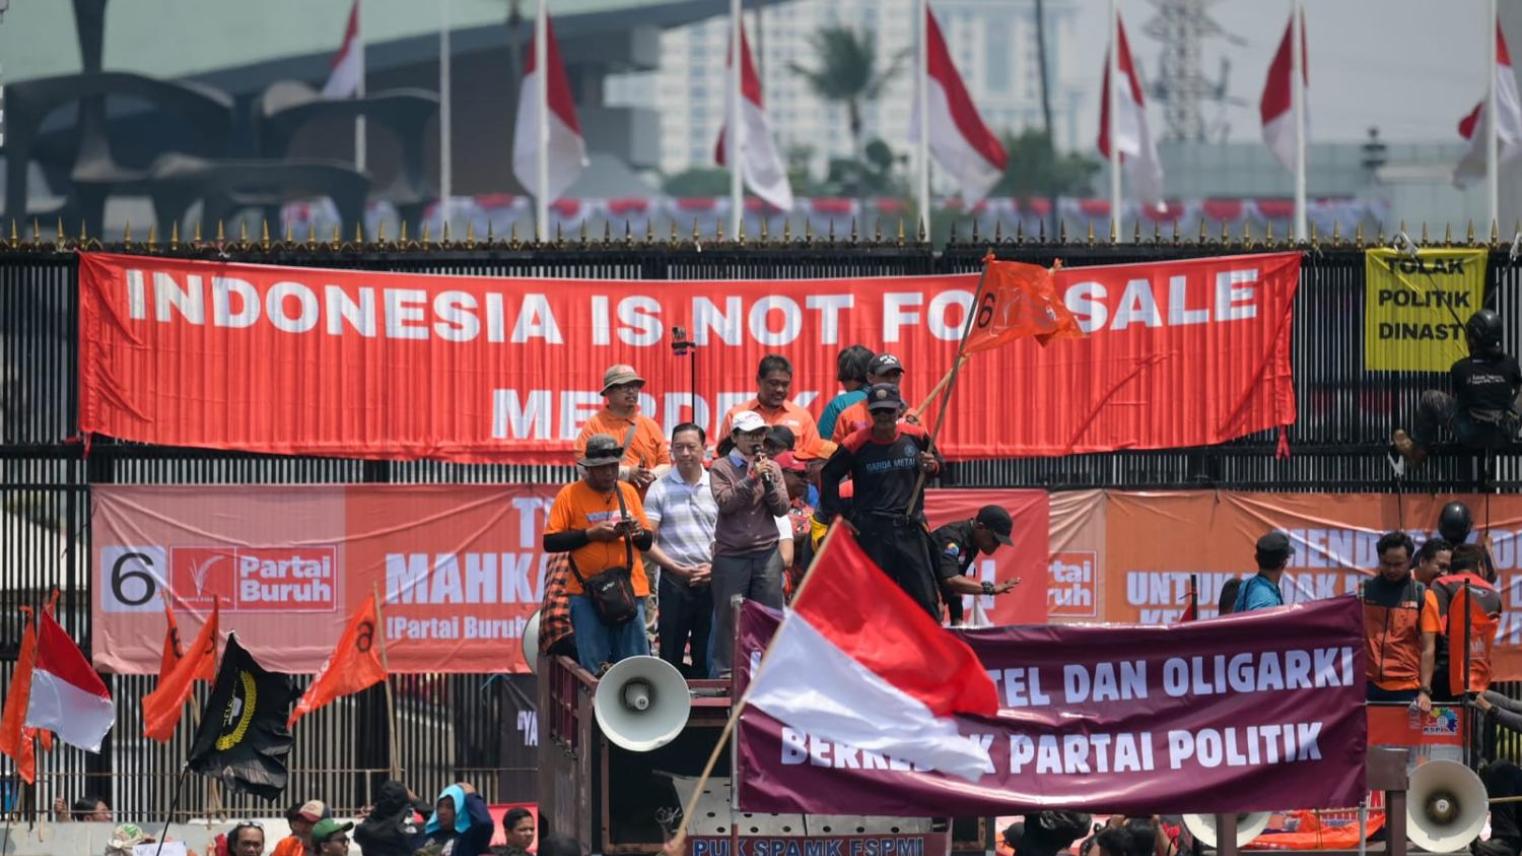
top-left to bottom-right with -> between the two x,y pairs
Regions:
749,524 -> 998,781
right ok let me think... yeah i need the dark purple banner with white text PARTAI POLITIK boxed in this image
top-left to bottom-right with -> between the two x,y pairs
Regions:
735,597 -> 1368,816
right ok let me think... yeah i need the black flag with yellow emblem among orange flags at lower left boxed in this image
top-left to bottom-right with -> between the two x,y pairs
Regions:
187,634 -> 294,800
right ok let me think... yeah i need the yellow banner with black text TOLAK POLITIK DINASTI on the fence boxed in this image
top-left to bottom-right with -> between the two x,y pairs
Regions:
1364,248 -> 1487,372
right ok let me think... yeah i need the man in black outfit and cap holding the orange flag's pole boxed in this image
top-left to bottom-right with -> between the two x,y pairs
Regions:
814,384 -> 941,612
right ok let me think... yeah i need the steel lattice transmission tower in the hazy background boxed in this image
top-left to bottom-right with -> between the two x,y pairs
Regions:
1142,0 -> 1245,140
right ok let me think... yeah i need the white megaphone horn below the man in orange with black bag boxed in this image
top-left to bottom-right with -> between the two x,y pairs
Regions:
592,656 -> 693,752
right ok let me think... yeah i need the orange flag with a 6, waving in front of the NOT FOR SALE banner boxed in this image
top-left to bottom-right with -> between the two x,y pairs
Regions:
963,254 -> 1084,353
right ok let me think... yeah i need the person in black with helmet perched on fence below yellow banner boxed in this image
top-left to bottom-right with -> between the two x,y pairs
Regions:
1391,309 -> 1522,466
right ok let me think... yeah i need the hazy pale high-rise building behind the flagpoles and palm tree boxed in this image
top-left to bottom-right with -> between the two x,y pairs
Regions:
607,0 -> 1099,185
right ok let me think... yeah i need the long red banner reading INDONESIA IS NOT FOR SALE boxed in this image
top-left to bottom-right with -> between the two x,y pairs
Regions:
79,253 -> 1300,463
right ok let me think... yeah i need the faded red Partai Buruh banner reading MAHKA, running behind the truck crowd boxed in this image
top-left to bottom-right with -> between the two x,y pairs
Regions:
90,484 -> 1047,675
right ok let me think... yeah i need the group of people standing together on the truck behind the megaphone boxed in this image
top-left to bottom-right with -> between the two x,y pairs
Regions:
540,346 -> 1020,678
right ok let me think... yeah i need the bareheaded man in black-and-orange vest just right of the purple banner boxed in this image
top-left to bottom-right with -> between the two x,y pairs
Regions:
1359,532 -> 1443,713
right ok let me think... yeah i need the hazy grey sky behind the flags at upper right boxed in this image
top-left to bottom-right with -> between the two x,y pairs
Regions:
1076,0 -> 1491,143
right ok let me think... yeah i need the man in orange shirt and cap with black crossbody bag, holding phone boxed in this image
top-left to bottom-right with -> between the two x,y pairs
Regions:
543,434 -> 653,675
